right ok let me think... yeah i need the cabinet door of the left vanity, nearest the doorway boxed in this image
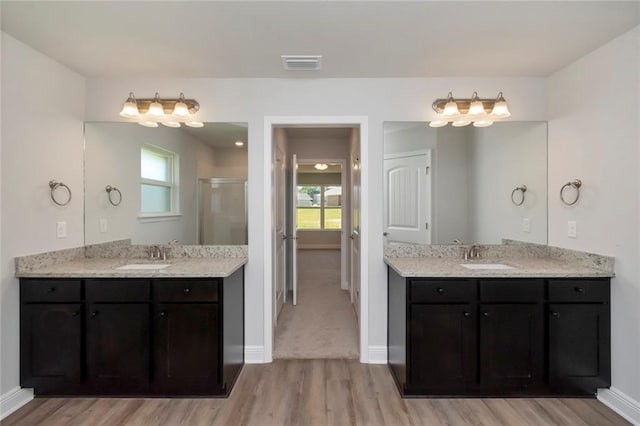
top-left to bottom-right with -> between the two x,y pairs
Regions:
153,303 -> 222,395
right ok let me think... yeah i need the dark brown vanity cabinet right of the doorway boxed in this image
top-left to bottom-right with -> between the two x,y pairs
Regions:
388,269 -> 610,396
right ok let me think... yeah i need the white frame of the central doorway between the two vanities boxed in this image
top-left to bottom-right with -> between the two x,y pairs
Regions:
262,116 -> 369,363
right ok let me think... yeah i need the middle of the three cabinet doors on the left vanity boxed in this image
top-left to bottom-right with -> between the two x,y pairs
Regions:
87,303 -> 150,395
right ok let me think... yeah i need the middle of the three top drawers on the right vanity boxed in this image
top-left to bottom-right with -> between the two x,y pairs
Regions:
480,279 -> 544,303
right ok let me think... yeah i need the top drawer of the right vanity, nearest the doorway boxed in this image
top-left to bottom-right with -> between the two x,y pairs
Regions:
409,280 -> 476,303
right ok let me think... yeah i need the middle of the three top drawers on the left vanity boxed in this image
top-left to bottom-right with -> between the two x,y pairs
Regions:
85,279 -> 150,302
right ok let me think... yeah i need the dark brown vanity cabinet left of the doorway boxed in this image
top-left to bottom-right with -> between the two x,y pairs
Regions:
20,268 -> 244,396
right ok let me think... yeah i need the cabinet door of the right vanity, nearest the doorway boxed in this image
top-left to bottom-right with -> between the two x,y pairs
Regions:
407,304 -> 476,393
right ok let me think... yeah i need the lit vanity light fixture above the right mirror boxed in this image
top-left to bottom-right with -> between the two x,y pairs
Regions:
429,92 -> 511,127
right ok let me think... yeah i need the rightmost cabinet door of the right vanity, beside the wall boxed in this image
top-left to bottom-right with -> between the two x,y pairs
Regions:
549,304 -> 611,395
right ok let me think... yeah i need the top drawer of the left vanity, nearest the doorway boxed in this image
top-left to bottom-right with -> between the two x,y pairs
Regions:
153,279 -> 219,302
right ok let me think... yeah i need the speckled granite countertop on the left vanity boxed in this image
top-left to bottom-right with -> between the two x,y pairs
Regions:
16,257 -> 247,278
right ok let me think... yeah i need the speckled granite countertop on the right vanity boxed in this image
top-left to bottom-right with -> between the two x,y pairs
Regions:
385,257 -> 613,278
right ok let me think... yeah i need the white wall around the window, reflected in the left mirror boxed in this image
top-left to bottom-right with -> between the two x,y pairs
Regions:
85,123 -> 218,244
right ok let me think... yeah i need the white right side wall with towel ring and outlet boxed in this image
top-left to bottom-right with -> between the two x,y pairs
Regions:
548,27 -> 640,412
